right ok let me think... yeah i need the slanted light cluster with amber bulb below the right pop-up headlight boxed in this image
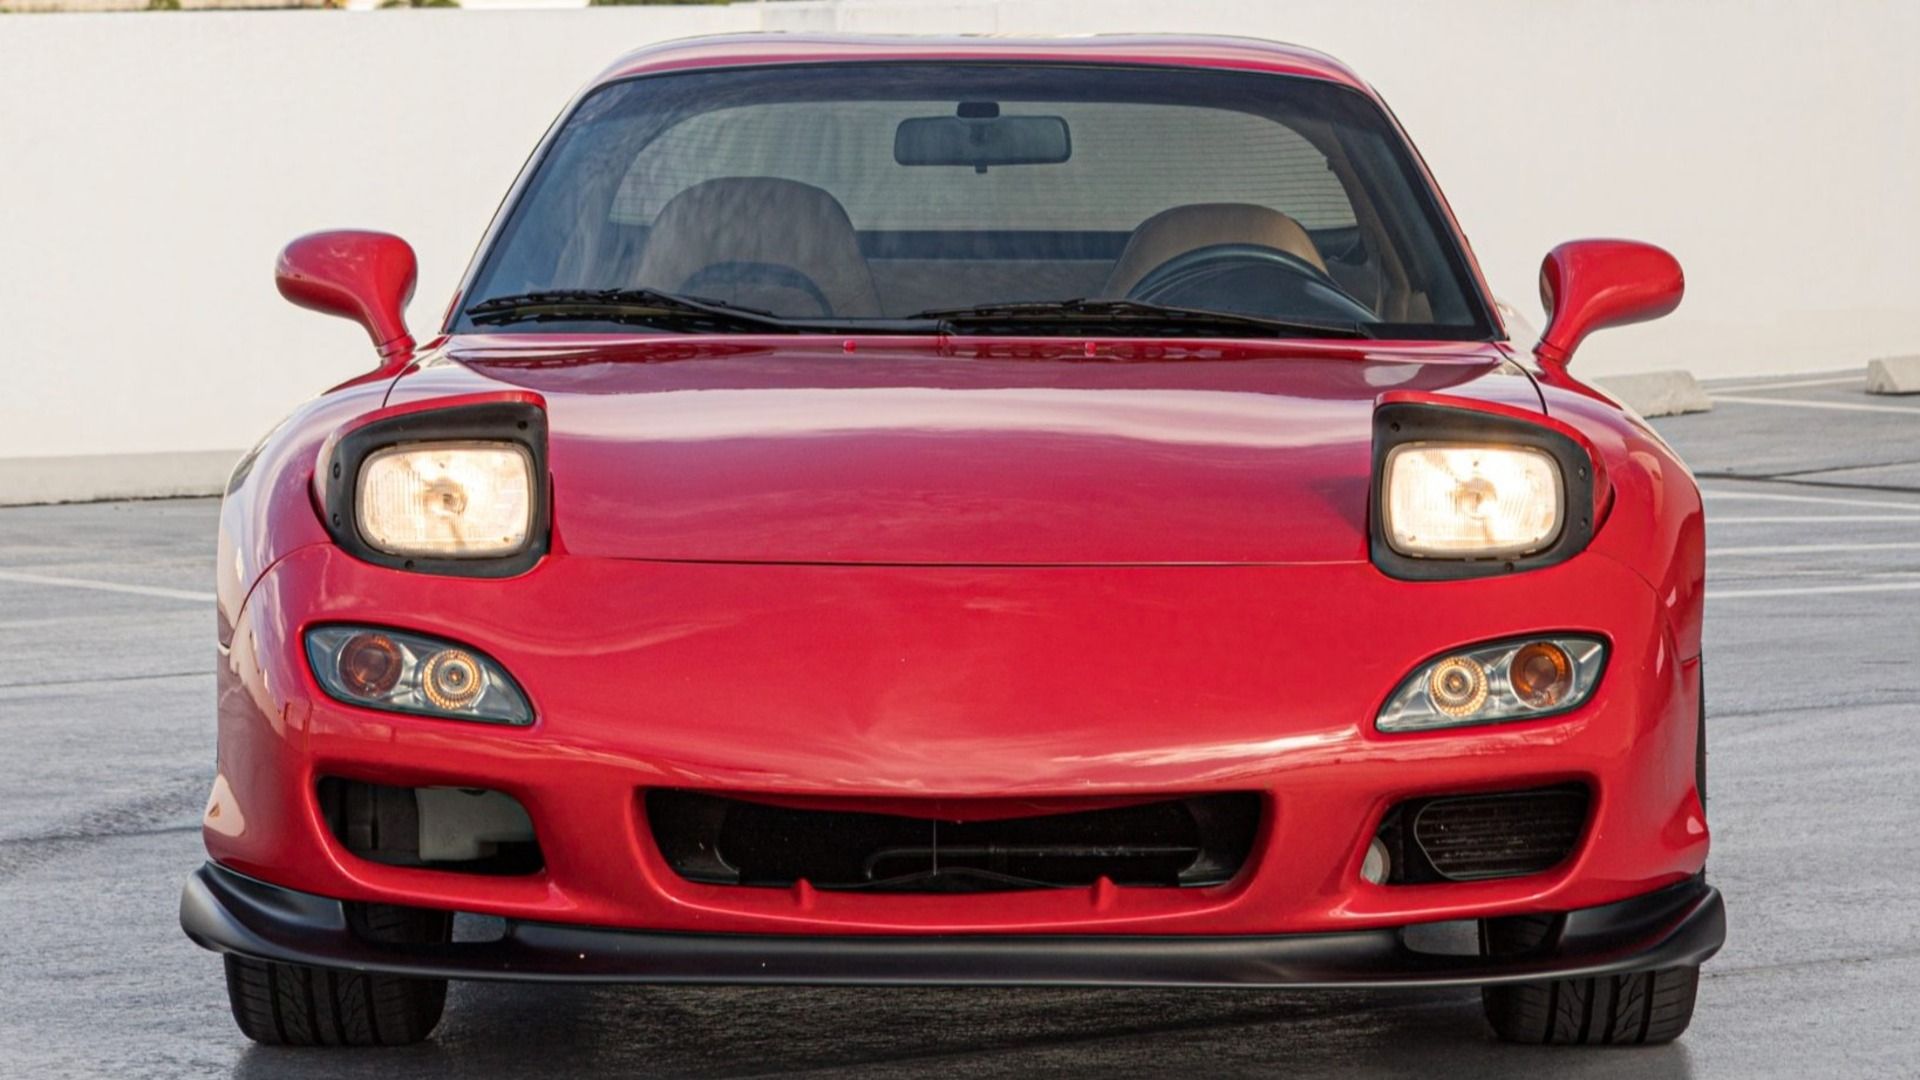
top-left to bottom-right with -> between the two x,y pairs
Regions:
1375,636 -> 1607,732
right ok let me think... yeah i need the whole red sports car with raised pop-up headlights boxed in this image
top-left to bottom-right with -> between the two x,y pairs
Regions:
180,37 -> 1724,1043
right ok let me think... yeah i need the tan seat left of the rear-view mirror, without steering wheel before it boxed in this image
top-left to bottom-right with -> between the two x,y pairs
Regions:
636,177 -> 879,317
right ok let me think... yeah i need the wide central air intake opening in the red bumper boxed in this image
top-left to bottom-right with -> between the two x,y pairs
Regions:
647,790 -> 1261,892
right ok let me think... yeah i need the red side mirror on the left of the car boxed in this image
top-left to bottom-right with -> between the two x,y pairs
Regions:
273,229 -> 419,357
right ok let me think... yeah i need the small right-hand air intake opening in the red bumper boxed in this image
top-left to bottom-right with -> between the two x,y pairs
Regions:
1380,784 -> 1590,884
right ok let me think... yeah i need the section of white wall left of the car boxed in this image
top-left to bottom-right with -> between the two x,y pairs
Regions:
0,6 -> 758,470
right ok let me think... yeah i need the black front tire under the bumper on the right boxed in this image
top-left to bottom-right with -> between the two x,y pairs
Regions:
1480,917 -> 1699,1045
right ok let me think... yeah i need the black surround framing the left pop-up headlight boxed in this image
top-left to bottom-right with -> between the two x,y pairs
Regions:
321,402 -> 553,578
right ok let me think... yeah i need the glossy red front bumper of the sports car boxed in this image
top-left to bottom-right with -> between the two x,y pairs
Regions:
205,546 -> 1709,940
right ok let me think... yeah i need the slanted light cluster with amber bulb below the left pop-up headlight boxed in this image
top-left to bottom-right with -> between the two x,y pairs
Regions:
307,626 -> 534,724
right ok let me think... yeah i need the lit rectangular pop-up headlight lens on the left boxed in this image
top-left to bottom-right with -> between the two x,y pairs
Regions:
355,442 -> 534,559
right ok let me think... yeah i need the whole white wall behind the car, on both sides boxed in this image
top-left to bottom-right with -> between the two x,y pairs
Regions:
0,0 -> 1920,476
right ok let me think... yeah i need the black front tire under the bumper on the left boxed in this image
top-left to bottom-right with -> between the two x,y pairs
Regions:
227,903 -> 451,1045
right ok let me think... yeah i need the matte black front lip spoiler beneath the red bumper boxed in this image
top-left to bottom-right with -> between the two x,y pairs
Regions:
180,863 -> 1726,988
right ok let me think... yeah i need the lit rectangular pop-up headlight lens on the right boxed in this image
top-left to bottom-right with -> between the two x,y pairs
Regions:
1386,444 -> 1565,559
